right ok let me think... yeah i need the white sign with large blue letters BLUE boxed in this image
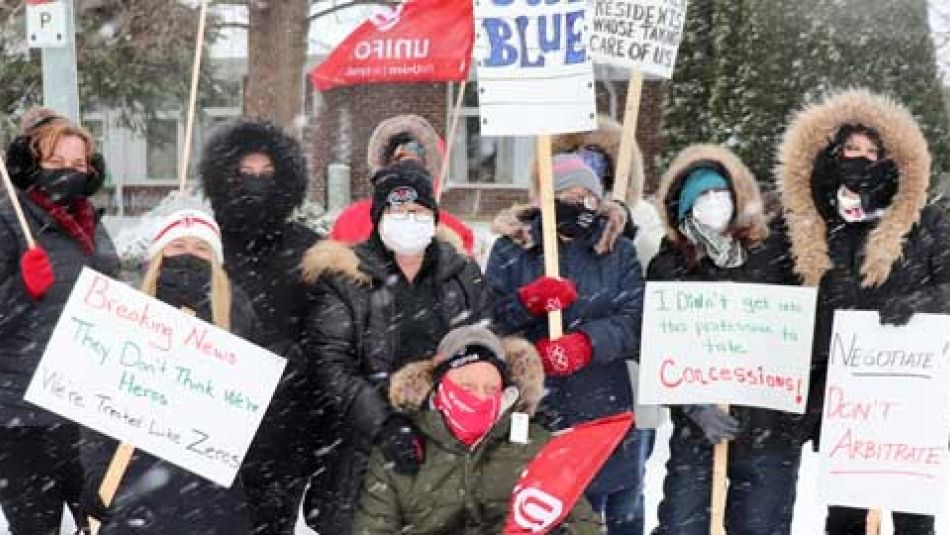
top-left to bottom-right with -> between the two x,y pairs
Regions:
474,0 -> 597,136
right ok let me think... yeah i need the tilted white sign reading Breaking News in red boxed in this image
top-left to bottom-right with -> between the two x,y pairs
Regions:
24,268 -> 285,487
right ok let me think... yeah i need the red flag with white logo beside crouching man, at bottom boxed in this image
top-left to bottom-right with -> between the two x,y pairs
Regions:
504,412 -> 633,535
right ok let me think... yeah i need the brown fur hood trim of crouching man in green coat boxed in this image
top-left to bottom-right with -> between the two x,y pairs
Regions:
389,337 -> 544,414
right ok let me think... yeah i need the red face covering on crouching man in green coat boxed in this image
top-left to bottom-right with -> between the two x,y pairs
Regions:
434,377 -> 502,447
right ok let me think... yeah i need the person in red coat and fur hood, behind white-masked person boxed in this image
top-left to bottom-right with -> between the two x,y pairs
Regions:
330,115 -> 475,256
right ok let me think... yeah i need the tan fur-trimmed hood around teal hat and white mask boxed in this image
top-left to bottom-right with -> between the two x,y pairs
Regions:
657,144 -> 769,245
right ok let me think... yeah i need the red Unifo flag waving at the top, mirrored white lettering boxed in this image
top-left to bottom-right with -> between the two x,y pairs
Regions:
310,0 -> 474,91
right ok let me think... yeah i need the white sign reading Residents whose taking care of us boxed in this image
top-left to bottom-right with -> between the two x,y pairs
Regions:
587,0 -> 686,79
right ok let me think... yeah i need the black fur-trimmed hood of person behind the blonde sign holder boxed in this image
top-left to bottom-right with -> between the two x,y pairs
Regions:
198,119 -> 309,218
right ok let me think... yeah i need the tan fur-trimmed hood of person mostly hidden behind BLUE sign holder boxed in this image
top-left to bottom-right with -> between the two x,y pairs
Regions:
532,115 -> 644,203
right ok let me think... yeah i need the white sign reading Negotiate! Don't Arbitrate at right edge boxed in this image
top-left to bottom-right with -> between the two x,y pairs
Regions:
821,311 -> 950,514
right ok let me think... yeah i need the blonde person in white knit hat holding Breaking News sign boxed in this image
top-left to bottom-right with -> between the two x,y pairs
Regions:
82,210 -> 262,535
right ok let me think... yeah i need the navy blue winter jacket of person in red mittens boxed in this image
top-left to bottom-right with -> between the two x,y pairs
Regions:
485,208 -> 644,493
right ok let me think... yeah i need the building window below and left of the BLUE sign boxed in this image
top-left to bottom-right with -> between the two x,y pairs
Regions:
449,82 -> 535,187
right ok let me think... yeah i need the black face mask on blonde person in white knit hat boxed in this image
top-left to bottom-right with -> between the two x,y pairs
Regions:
155,254 -> 211,312
